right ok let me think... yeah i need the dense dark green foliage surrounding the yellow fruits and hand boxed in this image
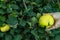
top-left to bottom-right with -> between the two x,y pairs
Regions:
0,0 -> 60,40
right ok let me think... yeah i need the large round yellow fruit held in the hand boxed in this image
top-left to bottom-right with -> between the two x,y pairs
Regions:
39,14 -> 54,29
